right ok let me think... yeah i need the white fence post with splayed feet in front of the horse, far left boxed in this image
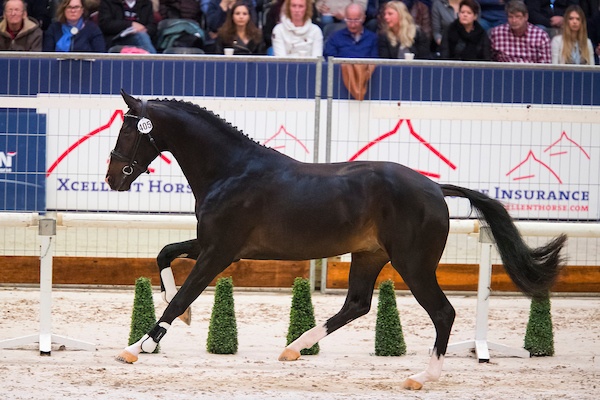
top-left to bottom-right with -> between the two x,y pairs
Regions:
0,218 -> 96,356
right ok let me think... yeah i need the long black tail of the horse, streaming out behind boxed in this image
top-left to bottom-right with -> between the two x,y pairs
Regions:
440,185 -> 567,297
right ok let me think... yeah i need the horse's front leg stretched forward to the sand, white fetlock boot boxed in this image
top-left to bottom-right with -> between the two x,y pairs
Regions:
116,254 -> 233,364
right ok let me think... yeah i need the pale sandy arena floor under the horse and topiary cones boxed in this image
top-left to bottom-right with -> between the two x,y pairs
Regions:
0,287 -> 600,400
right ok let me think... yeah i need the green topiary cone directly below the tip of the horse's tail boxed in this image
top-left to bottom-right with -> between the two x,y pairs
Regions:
524,294 -> 554,357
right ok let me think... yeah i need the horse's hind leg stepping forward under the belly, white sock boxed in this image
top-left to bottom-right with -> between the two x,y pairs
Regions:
279,251 -> 389,361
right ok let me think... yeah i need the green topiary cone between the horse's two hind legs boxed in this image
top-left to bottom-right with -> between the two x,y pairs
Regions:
375,280 -> 406,357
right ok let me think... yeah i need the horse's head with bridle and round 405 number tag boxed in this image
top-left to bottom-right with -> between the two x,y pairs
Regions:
106,90 -> 160,191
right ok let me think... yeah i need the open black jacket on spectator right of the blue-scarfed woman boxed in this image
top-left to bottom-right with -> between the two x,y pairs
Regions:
98,0 -> 156,48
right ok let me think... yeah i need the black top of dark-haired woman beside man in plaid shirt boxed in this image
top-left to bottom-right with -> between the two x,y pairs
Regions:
441,19 -> 492,61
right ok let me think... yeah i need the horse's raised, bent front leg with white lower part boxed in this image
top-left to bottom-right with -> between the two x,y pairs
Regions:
156,239 -> 200,325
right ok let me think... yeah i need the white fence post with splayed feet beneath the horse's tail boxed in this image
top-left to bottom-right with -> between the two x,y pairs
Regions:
448,226 -> 530,363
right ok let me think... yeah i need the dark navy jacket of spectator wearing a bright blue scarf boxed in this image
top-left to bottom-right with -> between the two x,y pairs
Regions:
42,21 -> 106,53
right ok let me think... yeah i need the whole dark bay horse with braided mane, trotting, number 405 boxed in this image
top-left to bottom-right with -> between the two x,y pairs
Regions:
106,92 -> 566,389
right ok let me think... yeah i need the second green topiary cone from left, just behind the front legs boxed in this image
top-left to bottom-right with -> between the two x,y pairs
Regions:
206,277 -> 238,354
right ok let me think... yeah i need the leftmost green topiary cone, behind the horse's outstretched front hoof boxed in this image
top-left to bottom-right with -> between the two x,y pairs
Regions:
128,277 -> 160,353
